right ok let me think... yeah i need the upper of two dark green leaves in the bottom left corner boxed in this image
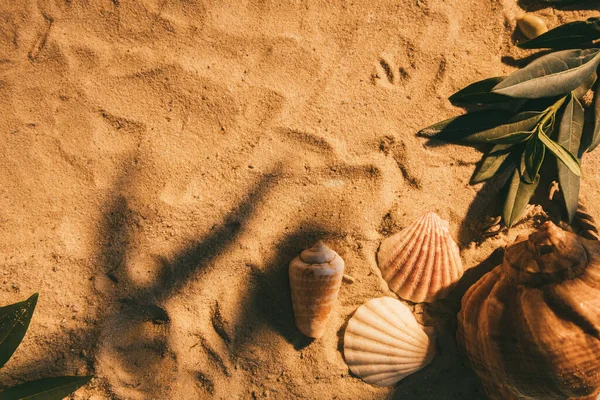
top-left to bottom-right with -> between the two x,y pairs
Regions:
0,293 -> 38,368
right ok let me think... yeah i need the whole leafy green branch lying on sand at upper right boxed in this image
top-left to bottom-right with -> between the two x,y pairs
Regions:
418,18 -> 600,227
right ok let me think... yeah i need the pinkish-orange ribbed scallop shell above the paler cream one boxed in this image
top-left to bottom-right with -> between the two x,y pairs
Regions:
377,212 -> 464,303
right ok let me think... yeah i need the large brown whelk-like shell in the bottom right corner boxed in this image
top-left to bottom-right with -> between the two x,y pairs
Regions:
457,222 -> 600,400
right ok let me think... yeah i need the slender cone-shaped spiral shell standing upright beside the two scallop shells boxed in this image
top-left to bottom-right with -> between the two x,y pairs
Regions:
289,241 -> 344,339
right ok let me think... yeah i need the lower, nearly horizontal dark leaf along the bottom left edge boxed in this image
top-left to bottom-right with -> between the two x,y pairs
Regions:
0,376 -> 92,400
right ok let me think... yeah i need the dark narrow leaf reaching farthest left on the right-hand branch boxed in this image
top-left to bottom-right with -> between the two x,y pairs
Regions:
418,110 -> 512,143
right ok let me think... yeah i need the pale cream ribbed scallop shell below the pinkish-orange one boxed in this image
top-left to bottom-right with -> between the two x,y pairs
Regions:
344,297 -> 435,386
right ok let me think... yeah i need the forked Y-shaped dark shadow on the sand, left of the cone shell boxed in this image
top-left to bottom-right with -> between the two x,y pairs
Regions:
91,162 -> 279,395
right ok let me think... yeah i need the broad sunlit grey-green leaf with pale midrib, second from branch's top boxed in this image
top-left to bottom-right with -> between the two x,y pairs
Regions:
493,49 -> 600,99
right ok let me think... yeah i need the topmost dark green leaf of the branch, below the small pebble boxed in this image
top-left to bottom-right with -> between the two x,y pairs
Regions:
518,18 -> 600,49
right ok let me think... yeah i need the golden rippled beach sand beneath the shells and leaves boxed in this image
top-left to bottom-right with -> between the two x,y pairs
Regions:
0,0 -> 600,399
